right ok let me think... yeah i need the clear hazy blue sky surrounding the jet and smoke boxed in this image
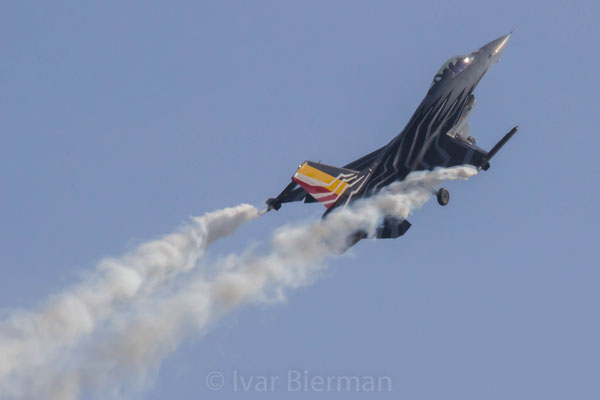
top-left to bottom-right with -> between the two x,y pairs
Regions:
0,0 -> 600,400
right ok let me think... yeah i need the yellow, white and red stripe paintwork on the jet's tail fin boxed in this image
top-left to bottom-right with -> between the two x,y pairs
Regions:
292,163 -> 348,208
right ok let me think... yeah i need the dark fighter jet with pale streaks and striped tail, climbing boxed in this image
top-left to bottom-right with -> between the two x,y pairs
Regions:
266,33 -> 518,246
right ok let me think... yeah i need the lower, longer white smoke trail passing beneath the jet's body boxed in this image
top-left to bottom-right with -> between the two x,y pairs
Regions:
0,166 -> 477,400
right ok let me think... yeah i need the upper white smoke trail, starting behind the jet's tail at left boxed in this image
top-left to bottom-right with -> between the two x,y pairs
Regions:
0,204 -> 258,398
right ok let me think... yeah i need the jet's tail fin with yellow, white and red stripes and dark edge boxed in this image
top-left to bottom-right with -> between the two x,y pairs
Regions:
292,161 -> 359,208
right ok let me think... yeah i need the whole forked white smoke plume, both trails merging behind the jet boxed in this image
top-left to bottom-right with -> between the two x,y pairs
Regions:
0,166 -> 477,399
